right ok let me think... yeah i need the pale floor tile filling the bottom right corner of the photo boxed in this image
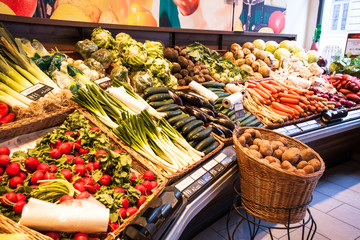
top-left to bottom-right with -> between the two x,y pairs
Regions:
311,208 -> 360,240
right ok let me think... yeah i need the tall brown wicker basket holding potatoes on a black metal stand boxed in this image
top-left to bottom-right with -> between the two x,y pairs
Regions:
233,127 -> 325,224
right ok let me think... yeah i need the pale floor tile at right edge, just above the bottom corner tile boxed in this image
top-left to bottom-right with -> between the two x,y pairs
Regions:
328,204 -> 360,229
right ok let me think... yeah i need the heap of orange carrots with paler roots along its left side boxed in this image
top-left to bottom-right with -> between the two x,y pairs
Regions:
244,80 -> 335,124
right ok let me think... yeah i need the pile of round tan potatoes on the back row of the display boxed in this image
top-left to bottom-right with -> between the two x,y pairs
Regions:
224,42 -> 273,79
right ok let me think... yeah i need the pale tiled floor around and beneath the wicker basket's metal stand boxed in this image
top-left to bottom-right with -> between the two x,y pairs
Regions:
193,160 -> 360,240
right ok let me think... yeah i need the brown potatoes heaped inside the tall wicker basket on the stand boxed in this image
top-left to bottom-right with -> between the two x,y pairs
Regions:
239,129 -> 321,175
